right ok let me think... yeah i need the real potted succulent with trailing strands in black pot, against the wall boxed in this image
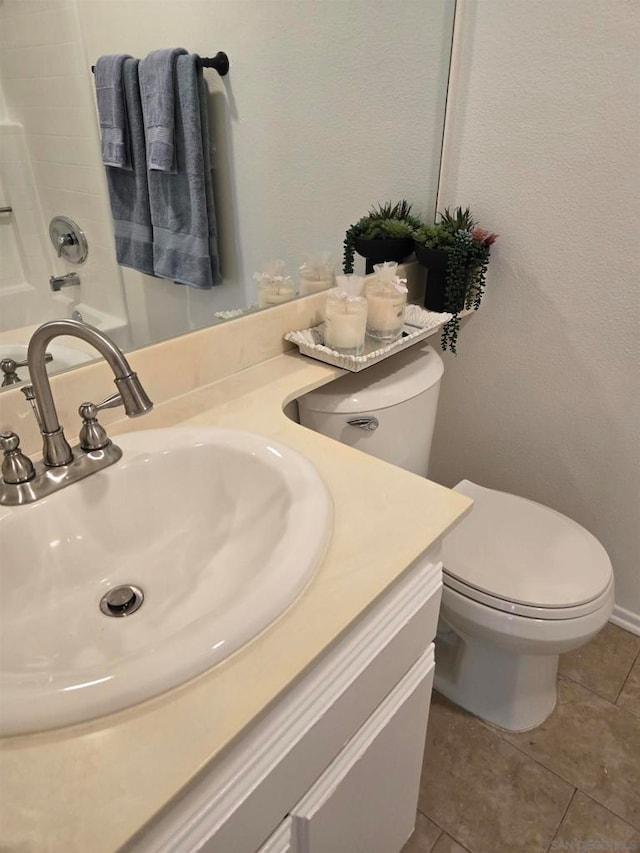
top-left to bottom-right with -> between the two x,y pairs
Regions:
414,207 -> 498,353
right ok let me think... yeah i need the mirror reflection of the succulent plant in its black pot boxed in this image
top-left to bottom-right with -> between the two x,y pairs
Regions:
343,199 -> 421,275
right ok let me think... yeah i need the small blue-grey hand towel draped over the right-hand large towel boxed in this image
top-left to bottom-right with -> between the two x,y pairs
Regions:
139,47 -> 187,173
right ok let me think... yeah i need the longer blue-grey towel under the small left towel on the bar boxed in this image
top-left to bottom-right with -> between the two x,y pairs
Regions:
106,58 -> 153,275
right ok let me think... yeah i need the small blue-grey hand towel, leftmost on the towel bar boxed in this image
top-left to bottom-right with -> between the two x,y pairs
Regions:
94,53 -> 131,169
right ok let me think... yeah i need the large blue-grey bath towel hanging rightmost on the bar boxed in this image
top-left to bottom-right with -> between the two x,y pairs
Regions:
148,54 -> 221,288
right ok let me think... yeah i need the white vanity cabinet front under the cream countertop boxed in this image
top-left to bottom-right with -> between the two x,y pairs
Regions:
125,557 -> 442,853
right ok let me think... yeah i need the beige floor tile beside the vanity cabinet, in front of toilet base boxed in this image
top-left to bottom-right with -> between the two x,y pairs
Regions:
419,693 -> 573,853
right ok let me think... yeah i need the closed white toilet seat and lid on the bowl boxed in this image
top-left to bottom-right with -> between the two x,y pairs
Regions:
441,480 -> 613,619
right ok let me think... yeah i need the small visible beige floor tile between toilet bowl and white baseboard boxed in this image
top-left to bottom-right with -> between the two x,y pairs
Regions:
560,622 -> 640,702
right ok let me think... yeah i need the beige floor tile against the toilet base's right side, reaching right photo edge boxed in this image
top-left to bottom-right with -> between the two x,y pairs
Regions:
502,678 -> 640,828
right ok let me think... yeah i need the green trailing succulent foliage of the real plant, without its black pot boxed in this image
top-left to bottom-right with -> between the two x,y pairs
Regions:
414,207 -> 498,353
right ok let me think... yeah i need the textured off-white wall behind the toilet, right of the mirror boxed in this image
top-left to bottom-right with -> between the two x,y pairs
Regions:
431,0 -> 640,630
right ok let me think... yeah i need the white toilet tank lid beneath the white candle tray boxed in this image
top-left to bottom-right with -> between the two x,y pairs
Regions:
298,344 -> 444,414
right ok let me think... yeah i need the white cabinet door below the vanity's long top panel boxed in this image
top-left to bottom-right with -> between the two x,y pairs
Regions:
291,650 -> 434,853
